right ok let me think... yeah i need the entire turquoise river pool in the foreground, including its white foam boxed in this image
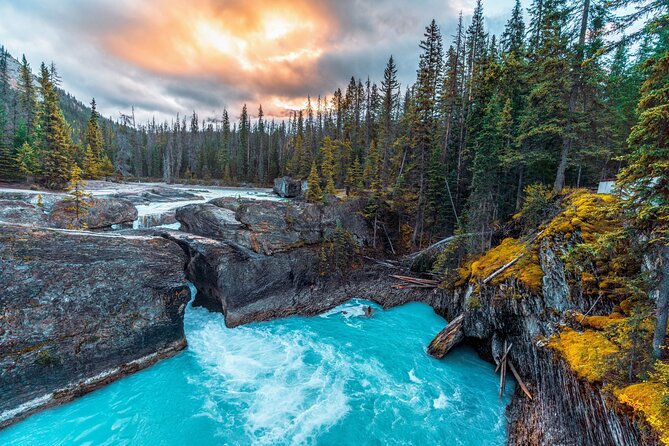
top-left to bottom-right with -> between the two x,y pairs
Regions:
0,294 -> 514,446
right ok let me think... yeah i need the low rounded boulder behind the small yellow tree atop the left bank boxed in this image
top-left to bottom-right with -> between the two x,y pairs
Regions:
48,198 -> 137,229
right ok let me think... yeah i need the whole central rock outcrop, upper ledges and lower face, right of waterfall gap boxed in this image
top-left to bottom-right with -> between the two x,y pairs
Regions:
170,199 -> 426,327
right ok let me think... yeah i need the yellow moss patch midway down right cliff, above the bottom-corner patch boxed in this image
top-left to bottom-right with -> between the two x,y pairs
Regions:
548,328 -> 618,382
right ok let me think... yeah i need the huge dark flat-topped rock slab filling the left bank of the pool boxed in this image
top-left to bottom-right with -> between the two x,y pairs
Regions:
0,224 -> 190,428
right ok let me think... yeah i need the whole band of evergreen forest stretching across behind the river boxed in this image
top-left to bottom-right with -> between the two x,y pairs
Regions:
0,0 -> 668,250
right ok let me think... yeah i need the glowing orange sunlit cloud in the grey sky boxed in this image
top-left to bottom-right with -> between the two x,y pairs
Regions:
103,0 -> 337,111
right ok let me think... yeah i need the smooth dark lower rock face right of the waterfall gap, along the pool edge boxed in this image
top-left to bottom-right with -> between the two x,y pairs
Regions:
165,231 -> 422,327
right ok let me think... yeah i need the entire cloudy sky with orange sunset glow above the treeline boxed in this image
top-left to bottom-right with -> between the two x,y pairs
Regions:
0,0 -> 528,120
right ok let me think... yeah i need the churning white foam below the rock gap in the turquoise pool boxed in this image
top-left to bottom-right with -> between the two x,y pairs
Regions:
186,308 -> 351,445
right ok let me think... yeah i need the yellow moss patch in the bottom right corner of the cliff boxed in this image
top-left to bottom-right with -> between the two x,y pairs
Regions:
616,382 -> 669,445
